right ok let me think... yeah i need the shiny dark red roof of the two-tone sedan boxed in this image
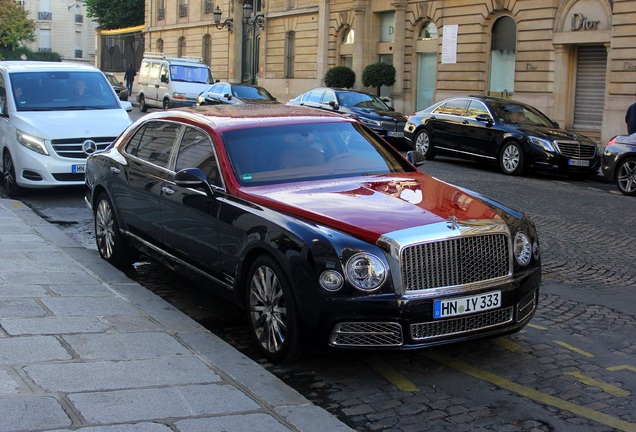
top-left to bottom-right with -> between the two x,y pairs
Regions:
142,104 -> 353,132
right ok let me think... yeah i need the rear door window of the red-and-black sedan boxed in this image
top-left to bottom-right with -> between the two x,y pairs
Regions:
126,122 -> 181,168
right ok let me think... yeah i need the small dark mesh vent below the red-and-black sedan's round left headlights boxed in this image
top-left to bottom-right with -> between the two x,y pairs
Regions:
331,322 -> 402,347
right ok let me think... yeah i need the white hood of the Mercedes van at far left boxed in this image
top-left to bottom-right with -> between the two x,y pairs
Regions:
11,108 -> 132,140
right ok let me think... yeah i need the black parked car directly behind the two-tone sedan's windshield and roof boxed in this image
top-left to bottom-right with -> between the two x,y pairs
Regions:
287,87 -> 406,148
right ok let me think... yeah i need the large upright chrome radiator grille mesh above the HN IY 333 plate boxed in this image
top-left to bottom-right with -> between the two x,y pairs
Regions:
401,234 -> 511,292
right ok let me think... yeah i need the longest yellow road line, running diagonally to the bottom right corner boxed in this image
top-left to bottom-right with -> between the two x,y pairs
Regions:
425,352 -> 636,432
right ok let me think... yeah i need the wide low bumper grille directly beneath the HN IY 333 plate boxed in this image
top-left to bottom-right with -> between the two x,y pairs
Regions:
411,306 -> 513,341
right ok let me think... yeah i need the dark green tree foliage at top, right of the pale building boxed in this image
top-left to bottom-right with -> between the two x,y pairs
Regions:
84,0 -> 145,30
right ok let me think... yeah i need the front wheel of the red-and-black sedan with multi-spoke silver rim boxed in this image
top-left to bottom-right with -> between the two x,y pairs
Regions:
247,256 -> 301,363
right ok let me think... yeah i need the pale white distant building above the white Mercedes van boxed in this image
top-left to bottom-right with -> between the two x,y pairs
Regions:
14,0 -> 97,64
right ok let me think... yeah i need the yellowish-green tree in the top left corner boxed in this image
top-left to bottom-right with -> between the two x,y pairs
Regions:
0,0 -> 35,51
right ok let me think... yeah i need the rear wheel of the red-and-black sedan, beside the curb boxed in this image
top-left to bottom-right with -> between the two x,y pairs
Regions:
95,193 -> 137,268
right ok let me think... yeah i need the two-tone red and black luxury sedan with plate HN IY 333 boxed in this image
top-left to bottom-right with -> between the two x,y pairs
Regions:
86,105 -> 541,361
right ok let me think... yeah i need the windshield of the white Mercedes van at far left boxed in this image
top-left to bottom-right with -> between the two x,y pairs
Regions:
11,71 -> 120,111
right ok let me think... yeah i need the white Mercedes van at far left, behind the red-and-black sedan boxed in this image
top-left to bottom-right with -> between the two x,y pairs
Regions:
0,61 -> 132,197
